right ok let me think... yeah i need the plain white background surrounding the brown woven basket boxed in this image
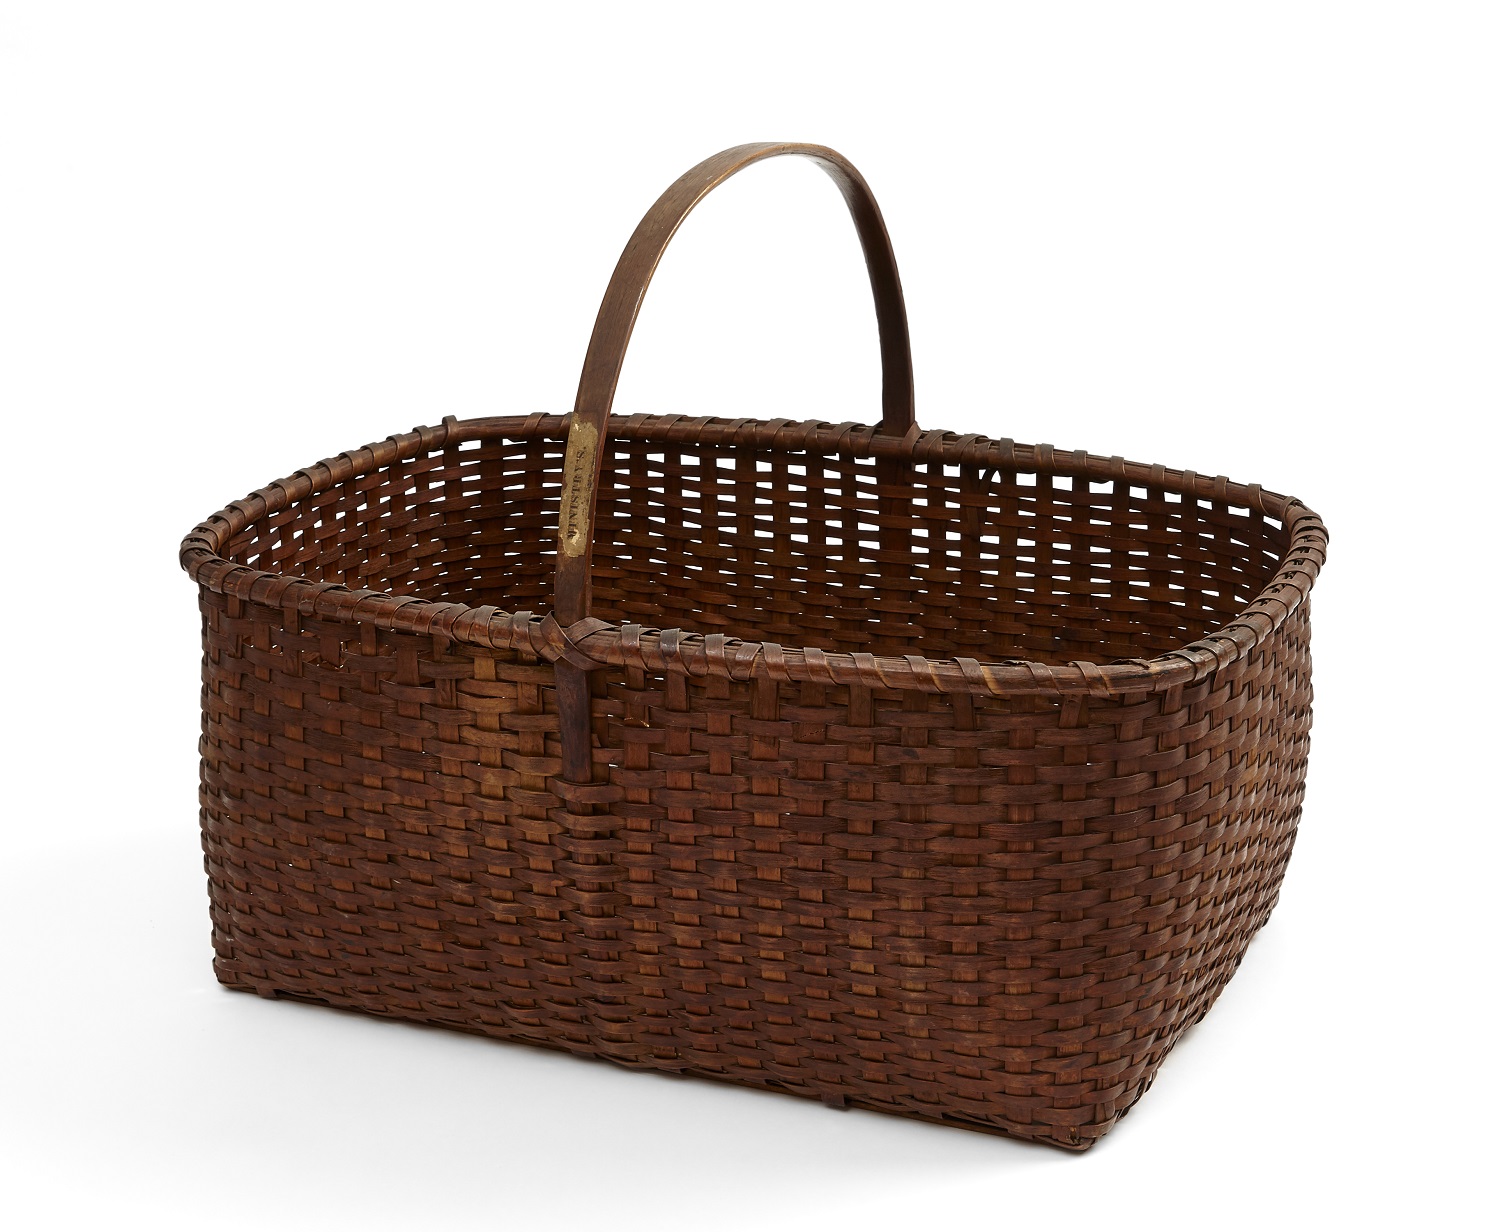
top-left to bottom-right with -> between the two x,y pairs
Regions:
0,2 -> 1500,1232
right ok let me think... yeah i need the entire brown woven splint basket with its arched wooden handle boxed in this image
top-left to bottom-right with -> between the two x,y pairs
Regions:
182,144 -> 1326,1148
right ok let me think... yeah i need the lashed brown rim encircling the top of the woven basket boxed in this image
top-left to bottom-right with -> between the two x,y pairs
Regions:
179,414 -> 1328,698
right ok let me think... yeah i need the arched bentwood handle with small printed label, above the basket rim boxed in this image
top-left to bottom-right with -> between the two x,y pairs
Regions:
555,141 -> 915,627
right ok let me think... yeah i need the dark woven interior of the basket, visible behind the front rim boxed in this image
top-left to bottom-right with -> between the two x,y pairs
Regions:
227,420 -> 1289,663
